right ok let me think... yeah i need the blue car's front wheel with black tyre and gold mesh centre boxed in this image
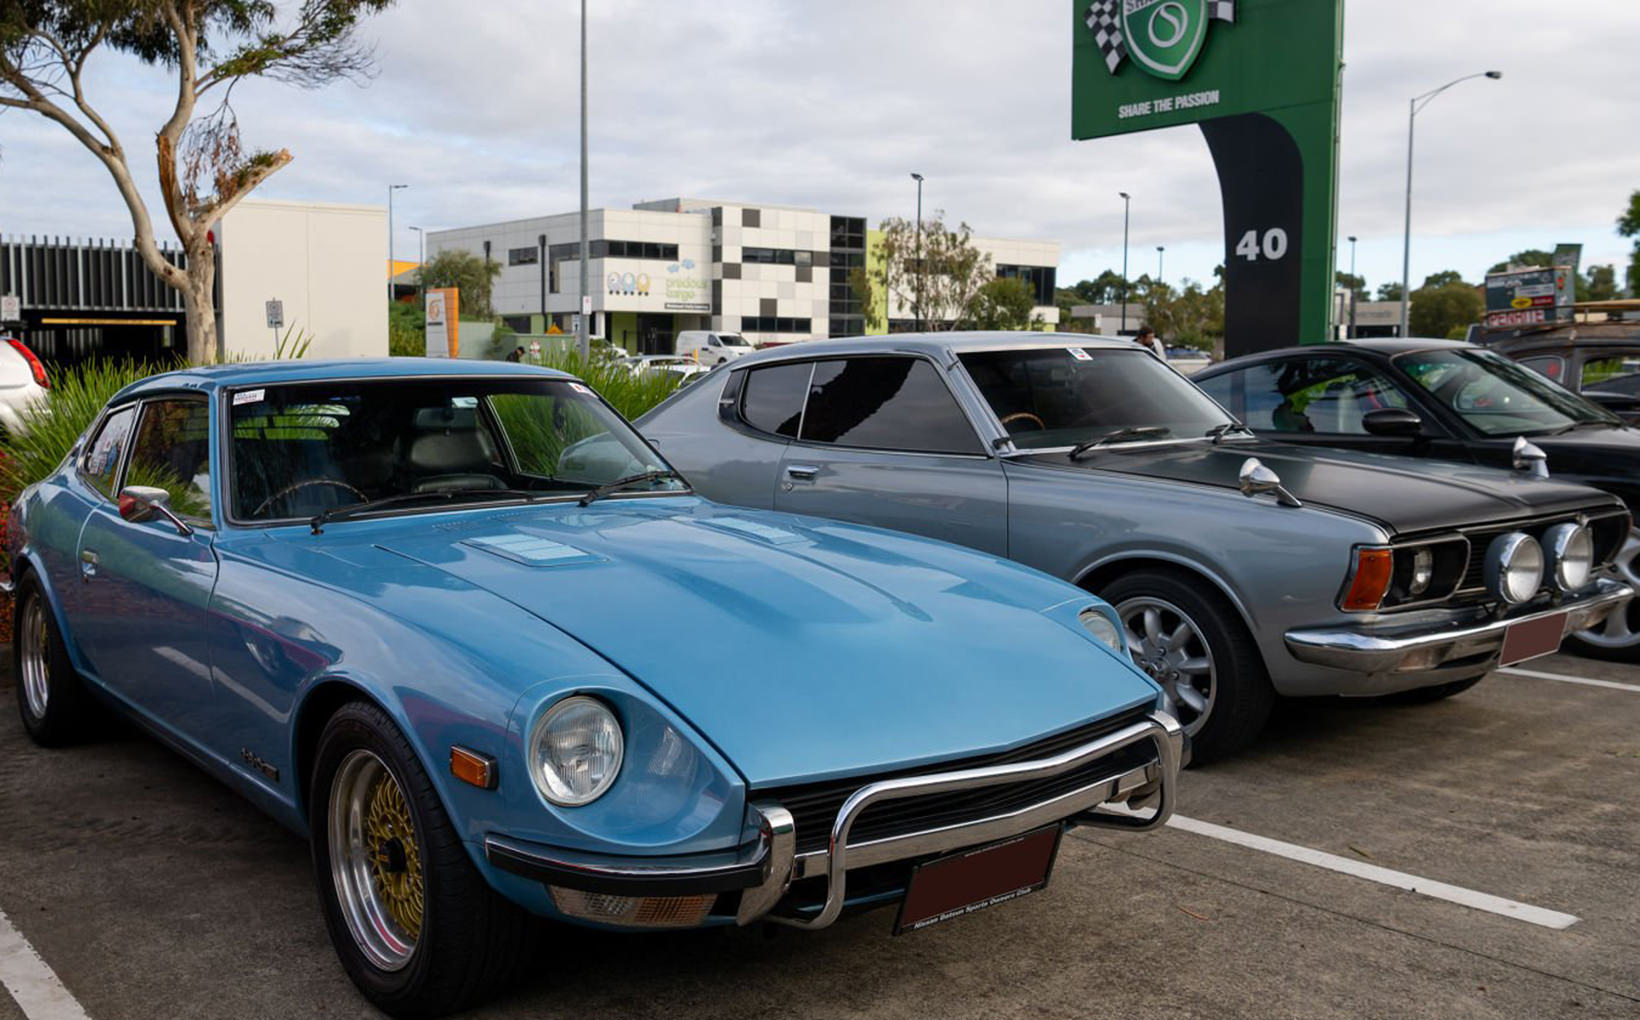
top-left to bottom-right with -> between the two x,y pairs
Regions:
308,702 -> 533,1017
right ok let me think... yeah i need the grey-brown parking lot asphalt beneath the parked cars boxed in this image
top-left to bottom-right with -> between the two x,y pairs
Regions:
0,656 -> 1640,1020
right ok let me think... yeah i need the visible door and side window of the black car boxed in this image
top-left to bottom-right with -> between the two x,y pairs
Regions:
1199,354 -> 1450,456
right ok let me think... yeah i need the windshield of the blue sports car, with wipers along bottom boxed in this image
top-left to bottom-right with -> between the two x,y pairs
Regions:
228,377 -> 684,521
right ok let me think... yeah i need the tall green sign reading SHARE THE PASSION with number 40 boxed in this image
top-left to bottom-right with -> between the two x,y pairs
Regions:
1071,0 -> 1343,356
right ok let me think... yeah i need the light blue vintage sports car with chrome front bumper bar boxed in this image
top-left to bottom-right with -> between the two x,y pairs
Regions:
8,359 -> 1184,1015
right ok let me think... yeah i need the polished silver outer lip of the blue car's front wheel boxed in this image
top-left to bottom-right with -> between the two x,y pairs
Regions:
328,748 -> 417,972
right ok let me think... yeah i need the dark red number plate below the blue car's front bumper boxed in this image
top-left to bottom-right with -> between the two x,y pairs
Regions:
894,825 -> 1064,935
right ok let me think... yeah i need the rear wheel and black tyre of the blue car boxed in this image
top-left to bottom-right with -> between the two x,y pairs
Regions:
11,574 -> 97,748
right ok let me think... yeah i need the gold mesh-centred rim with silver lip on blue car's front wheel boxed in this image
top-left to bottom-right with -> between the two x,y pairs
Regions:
330,748 -> 423,971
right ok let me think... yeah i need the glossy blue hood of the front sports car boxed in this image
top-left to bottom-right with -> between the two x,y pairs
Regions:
369,497 -> 1156,787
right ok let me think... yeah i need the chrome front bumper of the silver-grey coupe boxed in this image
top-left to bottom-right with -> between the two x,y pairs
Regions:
1286,577 -> 1635,674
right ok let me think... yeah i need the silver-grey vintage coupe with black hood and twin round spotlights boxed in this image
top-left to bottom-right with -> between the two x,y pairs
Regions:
638,333 -> 1632,761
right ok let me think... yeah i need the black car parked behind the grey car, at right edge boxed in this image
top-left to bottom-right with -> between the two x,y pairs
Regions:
1196,338 -> 1640,663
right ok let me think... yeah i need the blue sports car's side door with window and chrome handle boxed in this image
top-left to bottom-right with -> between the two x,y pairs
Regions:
66,395 -> 216,736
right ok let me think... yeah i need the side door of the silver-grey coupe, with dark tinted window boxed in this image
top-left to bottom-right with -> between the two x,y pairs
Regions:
774,354 -> 1009,556
